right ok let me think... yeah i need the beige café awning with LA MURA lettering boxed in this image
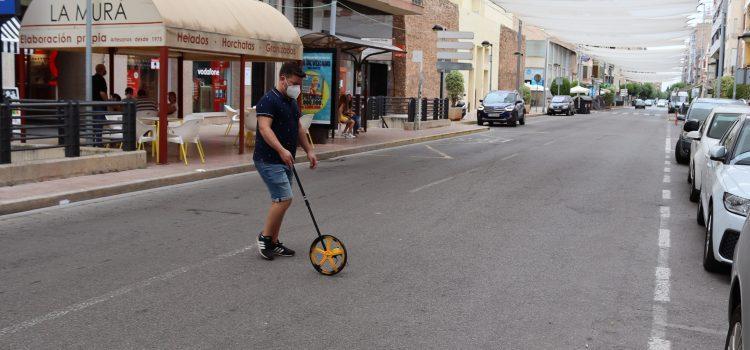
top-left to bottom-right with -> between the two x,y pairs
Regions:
20,0 -> 302,60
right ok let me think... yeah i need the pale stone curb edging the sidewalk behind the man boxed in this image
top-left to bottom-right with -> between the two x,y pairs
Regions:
0,127 -> 489,215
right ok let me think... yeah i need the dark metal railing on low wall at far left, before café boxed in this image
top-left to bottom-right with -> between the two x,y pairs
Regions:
0,100 -> 136,164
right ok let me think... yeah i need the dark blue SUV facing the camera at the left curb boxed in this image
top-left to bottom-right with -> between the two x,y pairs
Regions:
477,91 -> 526,126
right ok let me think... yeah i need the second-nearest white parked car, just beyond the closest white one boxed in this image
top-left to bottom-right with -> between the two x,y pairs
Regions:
685,105 -> 750,202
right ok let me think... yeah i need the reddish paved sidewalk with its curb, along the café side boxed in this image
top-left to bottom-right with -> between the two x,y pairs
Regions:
0,123 -> 488,215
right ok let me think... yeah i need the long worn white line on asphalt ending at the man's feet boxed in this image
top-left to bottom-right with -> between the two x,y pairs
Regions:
0,245 -> 255,337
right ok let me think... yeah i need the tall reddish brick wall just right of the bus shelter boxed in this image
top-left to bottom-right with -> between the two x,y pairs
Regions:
393,0 -> 458,98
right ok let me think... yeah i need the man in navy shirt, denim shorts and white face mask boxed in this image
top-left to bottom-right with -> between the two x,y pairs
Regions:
253,62 -> 318,260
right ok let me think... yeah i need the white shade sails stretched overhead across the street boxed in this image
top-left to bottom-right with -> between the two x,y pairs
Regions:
492,0 -> 698,81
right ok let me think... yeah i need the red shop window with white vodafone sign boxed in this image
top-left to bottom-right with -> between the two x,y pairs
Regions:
193,61 -> 231,113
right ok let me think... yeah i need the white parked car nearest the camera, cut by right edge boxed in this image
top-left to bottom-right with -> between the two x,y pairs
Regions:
697,116 -> 750,271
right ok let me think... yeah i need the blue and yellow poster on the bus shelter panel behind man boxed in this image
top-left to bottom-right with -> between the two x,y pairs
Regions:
302,52 -> 336,125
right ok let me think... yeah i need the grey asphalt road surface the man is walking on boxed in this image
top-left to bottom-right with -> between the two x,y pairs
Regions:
0,108 -> 728,349
